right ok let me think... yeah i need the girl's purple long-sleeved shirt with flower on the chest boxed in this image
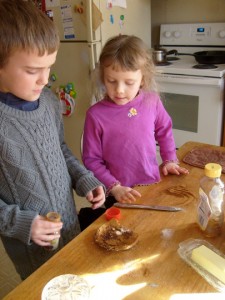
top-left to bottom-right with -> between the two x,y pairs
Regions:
83,91 -> 177,188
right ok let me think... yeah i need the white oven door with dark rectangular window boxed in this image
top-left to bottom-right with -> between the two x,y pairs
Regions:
156,74 -> 224,148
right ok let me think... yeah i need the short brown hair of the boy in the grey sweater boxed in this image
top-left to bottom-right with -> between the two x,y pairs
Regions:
0,0 -> 59,68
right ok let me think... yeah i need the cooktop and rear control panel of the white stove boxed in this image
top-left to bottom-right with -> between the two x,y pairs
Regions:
156,23 -> 225,78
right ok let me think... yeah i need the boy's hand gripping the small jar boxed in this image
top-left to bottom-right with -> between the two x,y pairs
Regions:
31,215 -> 63,246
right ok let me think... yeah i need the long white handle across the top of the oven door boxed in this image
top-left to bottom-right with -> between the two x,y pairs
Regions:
155,73 -> 224,87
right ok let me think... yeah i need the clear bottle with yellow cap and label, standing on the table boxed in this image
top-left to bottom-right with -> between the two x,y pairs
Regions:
197,163 -> 224,237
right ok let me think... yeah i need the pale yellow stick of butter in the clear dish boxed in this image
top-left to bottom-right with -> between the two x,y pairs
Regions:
191,245 -> 225,283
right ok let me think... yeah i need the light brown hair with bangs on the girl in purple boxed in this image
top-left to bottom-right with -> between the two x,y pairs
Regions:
92,35 -> 157,101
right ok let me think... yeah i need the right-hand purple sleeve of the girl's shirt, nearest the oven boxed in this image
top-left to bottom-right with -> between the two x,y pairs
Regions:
155,95 -> 177,161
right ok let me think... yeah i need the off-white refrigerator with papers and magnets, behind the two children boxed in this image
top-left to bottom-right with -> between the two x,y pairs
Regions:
45,0 -> 151,160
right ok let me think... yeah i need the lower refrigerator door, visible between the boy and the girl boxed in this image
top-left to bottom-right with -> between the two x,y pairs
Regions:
51,43 -> 95,159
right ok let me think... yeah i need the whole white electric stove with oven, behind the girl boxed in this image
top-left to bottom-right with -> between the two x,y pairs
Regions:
156,23 -> 225,152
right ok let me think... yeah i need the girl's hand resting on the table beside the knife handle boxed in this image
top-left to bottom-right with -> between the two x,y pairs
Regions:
110,185 -> 141,203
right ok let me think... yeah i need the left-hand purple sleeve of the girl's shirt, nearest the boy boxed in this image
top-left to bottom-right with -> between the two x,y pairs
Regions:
82,111 -> 118,189
